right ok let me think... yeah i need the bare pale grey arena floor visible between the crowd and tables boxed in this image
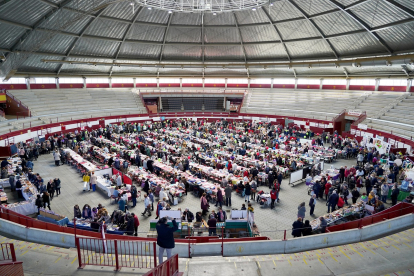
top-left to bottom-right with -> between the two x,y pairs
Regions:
10,151 -> 382,239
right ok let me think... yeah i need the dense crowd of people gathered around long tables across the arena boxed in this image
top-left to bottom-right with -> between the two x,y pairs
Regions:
5,119 -> 410,240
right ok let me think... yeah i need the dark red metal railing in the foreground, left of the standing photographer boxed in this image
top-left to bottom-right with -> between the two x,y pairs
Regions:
75,237 -> 157,270
